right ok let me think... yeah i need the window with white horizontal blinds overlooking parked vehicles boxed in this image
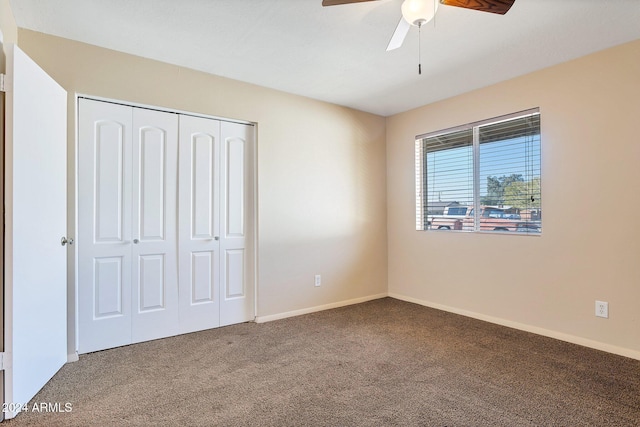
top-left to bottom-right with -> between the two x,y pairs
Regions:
416,109 -> 542,235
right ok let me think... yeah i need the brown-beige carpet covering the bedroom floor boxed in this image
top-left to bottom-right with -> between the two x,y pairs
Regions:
5,298 -> 640,427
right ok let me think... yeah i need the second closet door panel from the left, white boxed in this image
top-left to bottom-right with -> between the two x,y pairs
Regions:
132,108 -> 179,342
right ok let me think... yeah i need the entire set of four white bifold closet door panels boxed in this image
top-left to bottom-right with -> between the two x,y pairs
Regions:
78,99 -> 254,353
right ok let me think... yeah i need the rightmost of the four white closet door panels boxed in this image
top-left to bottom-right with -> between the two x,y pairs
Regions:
220,122 -> 255,326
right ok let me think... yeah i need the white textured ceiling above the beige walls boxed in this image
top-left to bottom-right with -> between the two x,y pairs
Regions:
11,0 -> 640,116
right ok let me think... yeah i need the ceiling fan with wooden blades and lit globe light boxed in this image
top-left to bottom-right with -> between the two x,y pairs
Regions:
322,0 -> 515,51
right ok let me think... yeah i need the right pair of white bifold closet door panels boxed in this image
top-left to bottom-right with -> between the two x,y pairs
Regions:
179,115 -> 254,332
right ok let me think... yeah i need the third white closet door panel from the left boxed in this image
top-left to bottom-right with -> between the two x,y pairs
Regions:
178,115 -> 220,333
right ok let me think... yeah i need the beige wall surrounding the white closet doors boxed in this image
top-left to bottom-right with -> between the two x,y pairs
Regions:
18,29 -> 387,354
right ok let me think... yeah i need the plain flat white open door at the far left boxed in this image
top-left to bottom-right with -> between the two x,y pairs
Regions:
4,45 -> 68,418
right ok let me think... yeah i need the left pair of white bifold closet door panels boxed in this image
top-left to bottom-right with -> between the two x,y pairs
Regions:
78,99 -> 179,353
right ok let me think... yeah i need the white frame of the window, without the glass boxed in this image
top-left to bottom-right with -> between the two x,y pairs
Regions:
415,107 -> 542,236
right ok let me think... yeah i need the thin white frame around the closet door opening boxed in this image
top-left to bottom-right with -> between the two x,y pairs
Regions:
68,92 -> 259,361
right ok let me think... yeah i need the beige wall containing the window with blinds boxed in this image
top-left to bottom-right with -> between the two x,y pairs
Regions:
387,41 -> 640,358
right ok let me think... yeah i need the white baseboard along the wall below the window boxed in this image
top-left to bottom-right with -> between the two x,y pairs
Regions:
389,292 -> 640,360
